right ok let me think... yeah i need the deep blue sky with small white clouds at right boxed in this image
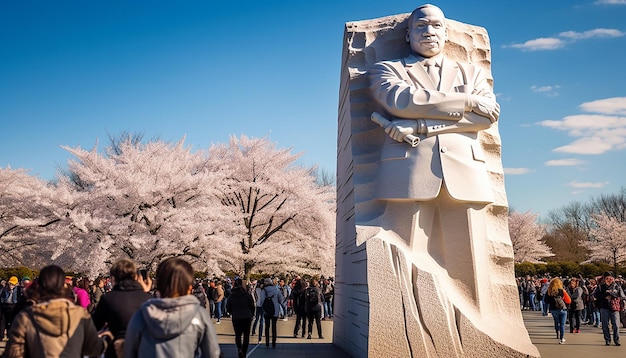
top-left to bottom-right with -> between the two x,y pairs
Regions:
0,0 -> 626,216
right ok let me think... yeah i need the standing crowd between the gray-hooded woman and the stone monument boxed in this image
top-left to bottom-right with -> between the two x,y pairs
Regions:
198,276 -> 335,357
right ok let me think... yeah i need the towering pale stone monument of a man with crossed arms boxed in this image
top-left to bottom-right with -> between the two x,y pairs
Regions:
334,4 -> 539,358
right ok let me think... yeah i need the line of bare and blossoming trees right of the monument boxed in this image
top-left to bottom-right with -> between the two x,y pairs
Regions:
509,188 -> 626,275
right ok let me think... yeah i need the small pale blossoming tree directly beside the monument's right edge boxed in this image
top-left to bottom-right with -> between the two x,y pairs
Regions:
509,211 -> 554,263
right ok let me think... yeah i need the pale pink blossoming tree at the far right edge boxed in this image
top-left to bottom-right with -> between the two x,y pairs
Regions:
581,213 -> 626,272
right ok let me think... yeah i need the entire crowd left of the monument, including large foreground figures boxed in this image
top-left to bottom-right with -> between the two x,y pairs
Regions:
0,258 -> 334,358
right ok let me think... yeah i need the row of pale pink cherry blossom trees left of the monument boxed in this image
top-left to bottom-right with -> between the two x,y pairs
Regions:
0,135 -> 335,276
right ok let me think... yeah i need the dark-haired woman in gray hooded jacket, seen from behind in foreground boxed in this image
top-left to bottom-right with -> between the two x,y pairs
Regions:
124,257 -> 221,358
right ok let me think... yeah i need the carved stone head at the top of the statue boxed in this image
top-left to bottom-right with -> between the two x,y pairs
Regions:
406,6 -> 448,57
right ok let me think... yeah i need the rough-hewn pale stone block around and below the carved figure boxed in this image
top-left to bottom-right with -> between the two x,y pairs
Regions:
333,14 -> 539,358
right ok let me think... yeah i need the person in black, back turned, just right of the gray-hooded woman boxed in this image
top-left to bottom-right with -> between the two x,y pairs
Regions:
226,278 -> 255,358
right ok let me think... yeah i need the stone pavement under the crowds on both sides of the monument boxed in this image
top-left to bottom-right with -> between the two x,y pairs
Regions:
0,311 -> 626,358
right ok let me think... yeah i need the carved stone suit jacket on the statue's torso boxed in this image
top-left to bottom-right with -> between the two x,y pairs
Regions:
369,55 -> 495,203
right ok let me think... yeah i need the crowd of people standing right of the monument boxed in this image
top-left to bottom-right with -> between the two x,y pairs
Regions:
517,271 -> 626,346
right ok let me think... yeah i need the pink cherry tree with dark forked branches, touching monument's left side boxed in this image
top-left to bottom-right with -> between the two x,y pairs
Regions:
211,136 -> 335,277
